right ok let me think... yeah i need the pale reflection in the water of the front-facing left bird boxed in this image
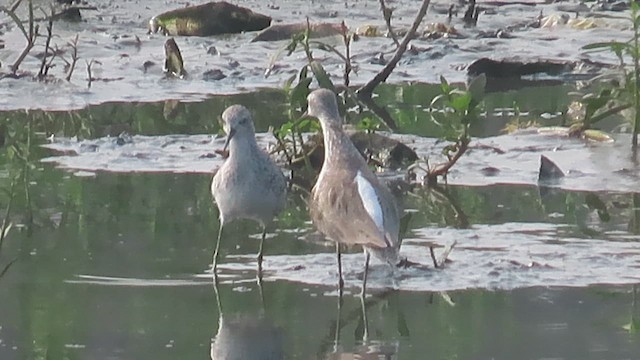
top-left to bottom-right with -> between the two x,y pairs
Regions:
211,277 -> 285,360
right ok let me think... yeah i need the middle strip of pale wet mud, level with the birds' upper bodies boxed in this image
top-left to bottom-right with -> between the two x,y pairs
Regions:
42,130 -> 640,192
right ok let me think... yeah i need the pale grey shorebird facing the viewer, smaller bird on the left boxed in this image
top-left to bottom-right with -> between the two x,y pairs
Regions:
211,105 -> 287,277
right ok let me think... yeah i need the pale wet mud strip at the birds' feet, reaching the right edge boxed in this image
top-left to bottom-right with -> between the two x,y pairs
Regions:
194,223 -> 640,295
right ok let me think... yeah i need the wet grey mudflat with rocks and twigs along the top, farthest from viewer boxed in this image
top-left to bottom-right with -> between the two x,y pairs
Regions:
0,0 -> 630,110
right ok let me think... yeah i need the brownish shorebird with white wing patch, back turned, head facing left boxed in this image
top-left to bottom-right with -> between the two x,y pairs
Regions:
307,89 -> 400,296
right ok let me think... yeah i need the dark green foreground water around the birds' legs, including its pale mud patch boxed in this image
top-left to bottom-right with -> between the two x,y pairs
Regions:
0,164 -> 640,359
